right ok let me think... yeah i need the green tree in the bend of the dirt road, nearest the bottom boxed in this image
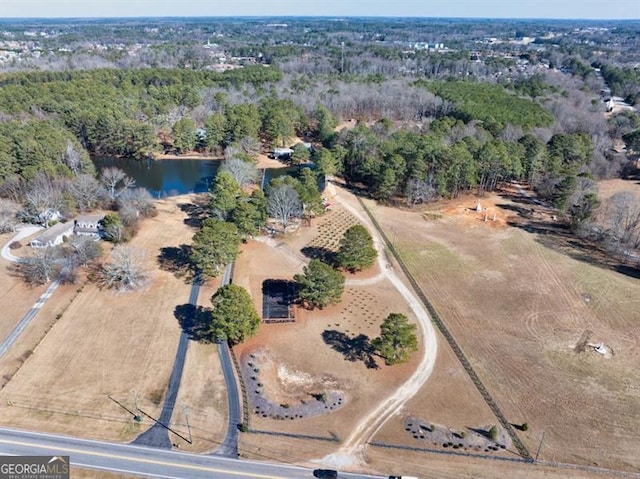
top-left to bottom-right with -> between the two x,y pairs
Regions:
372,313 -> 418,365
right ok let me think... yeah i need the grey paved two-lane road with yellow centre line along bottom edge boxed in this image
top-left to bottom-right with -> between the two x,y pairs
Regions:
0,428 -> 380,479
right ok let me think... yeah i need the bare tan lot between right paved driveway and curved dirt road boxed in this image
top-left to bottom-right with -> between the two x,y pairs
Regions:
234,208 -> 418,450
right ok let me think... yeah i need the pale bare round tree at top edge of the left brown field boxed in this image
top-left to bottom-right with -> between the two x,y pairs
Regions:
100,245 -> 148,291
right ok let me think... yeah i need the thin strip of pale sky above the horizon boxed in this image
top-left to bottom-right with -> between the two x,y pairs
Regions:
0,0 -> 640,19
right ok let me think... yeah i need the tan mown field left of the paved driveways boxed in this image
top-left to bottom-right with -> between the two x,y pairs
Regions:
0,198 -> 229,448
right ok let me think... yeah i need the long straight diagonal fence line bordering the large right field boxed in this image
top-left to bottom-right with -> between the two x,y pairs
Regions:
357,196 -> 533,462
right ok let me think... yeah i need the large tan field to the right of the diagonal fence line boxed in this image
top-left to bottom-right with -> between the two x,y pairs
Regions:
367,188 -> 640,472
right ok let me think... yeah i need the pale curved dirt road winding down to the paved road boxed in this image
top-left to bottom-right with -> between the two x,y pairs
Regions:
317,183 -> 438,468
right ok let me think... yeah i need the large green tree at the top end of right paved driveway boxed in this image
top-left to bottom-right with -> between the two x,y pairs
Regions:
191,218 -> 240,278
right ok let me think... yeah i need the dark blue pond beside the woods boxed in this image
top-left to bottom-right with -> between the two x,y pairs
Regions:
93,157 -> 220,198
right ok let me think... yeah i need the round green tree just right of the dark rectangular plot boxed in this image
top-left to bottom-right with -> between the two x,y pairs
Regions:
293,259 -> 344,309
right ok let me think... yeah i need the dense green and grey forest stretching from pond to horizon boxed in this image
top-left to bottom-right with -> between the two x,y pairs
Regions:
0,19 -> 640,256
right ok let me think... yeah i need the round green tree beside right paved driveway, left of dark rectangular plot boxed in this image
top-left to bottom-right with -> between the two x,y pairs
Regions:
210,284 -> 260,344
